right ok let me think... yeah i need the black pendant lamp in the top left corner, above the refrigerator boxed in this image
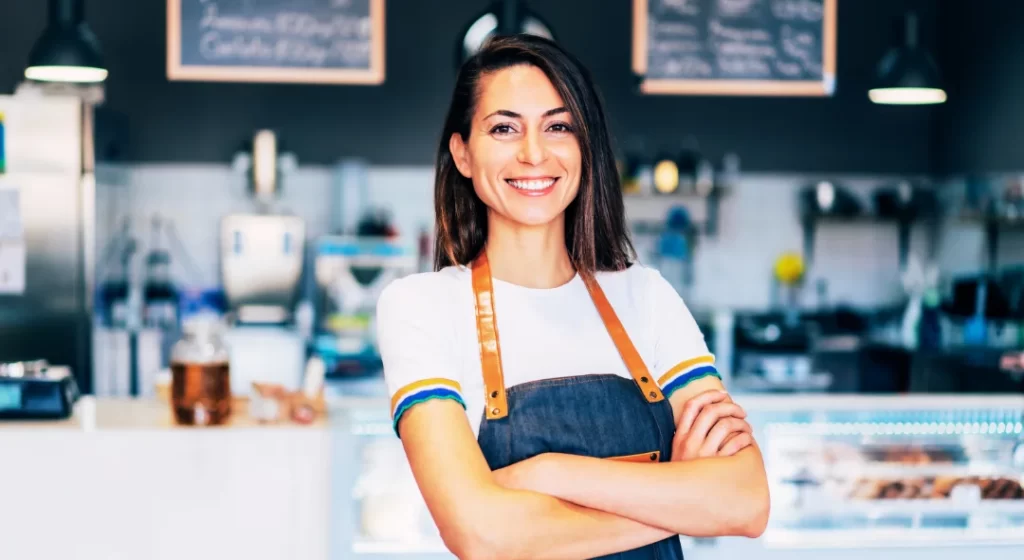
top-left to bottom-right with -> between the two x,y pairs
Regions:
25,0 -> 106,84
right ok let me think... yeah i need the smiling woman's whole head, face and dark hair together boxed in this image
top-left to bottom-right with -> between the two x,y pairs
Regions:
434,35 -> 633,278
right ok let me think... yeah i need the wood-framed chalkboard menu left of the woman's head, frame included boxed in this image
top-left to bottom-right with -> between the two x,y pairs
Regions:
167,0 -> 384,84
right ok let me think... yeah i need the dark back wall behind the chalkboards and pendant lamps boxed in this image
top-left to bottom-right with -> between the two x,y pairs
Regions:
0,0 -> 937,172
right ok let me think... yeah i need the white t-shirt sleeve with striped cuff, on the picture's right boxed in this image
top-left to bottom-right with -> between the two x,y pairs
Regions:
647,269 -> 722,398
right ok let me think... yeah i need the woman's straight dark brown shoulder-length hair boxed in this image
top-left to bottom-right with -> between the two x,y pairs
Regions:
434,35 -> 635,274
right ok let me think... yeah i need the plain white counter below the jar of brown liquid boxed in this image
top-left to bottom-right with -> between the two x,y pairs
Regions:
0,398 -> 330,560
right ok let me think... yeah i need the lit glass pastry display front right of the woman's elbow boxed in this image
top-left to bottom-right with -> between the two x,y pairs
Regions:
742,396 -> 1024,548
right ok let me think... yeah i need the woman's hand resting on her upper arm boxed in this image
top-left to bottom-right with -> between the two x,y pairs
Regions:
672,390 -> 754,461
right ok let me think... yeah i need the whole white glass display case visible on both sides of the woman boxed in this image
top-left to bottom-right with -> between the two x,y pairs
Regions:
331,395 -> 1024,560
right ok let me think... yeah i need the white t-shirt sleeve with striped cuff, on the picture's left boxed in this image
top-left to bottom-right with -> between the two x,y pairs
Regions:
377,277 -> 466,437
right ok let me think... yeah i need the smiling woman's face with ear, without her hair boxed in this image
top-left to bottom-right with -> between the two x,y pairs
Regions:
449,66 -> 582,230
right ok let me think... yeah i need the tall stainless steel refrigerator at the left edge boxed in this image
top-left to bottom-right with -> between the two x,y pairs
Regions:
0,90 -> 95,392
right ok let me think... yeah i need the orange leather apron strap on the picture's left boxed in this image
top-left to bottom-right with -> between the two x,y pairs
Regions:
472,251 -> 509,420
